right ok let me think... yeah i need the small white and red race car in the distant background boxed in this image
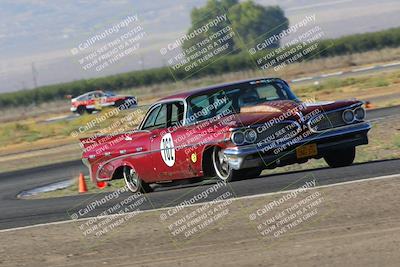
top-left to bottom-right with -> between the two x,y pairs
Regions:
71,91 -> 137,115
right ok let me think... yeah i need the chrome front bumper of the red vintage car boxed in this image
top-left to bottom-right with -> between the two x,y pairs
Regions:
224,122 -> 371,170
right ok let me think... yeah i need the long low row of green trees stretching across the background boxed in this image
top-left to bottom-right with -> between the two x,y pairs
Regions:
0,27 -> 400,107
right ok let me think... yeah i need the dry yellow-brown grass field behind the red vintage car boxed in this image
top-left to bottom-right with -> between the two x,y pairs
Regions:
0,48 -> 400,172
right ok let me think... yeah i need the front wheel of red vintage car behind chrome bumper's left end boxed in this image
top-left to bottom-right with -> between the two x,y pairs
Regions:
212,147 -> 243,183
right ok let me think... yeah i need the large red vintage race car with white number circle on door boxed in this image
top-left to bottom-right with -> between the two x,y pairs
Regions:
81,78 -> 371,192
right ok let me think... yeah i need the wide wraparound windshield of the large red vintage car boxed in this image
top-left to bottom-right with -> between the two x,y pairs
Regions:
187,80 -> 297,123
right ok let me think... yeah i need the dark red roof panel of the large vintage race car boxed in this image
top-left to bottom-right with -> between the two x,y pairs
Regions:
157,77 -> 283,103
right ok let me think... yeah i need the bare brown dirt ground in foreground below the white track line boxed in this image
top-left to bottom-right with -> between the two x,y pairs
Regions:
0,176 -> 400,267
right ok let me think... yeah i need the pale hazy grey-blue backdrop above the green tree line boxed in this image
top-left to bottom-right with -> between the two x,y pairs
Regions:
0,0 -> 400,92
